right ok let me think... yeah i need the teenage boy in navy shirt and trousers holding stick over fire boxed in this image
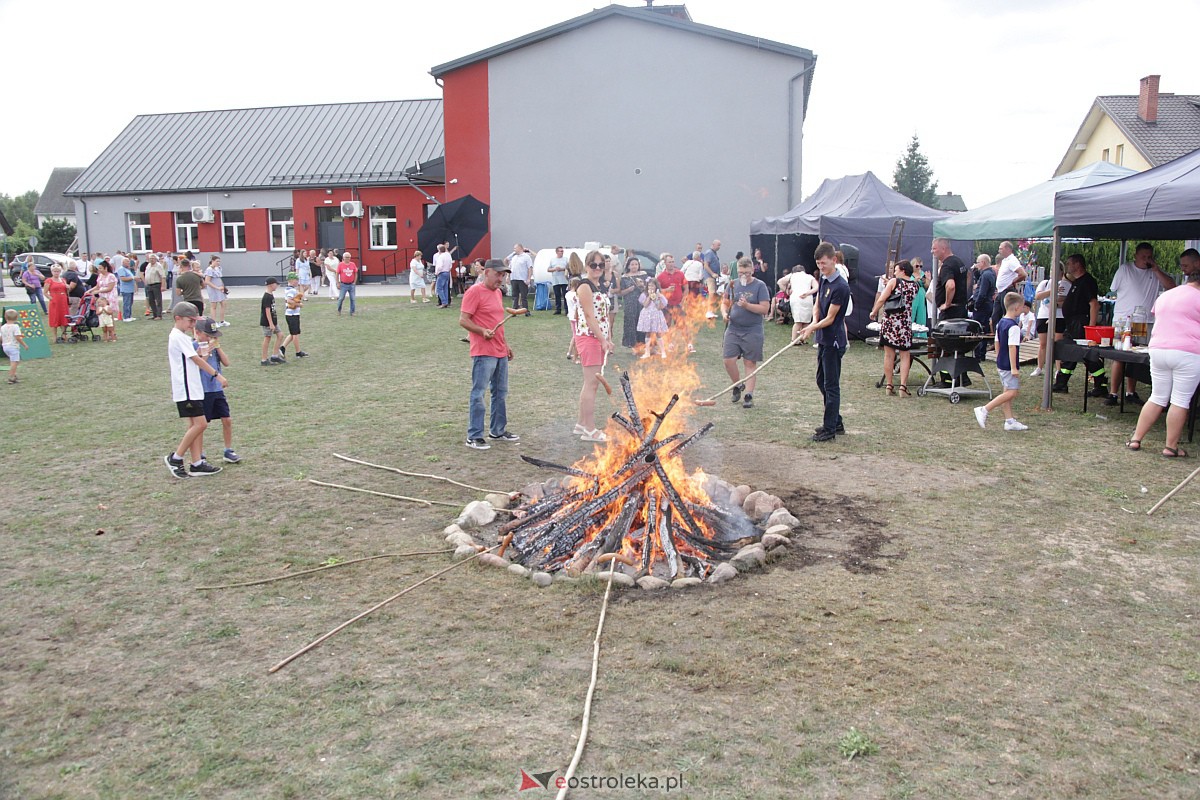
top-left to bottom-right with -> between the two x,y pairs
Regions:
800,241 -> 850,441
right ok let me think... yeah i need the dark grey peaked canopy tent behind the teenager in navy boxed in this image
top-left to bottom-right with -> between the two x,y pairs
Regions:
750,173 -> 972,337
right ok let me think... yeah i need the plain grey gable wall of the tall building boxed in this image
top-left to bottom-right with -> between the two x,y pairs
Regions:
482,17 -> 808,257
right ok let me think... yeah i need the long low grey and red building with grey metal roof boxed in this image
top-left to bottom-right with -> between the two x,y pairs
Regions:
65,100 -> 445,283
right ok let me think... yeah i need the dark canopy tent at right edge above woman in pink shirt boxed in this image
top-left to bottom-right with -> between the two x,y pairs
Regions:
1042,150 -> 1200,408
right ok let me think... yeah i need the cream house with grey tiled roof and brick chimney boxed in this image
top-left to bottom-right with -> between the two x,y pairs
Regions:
1054,76 -> 1200,176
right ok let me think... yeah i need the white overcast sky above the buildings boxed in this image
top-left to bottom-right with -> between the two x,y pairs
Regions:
0,0 -> 1200,207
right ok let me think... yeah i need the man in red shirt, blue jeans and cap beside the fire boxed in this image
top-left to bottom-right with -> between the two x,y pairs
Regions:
458,258 -> 521,450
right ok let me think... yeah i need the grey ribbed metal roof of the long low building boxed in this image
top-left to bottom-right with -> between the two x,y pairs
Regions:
66,100 -> 445,196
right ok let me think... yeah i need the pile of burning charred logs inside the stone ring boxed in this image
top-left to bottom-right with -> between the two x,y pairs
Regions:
500,373 -> 757,579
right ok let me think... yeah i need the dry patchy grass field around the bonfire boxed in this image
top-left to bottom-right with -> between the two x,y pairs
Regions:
0,297 -> 1200,799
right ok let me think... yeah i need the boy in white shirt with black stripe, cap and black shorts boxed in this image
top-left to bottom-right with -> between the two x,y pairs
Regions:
163,302 -> 228,477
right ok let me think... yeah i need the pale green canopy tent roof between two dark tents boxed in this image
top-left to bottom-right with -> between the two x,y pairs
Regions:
934,161 -> 1135,241
